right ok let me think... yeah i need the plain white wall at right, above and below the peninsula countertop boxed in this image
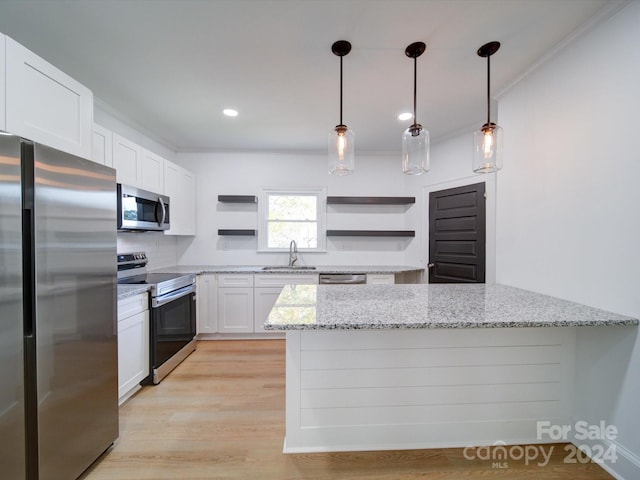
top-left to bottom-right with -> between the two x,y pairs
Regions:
497,2 -> 640,479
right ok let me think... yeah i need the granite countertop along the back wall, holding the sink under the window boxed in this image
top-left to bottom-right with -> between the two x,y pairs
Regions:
151,265 -> 424,275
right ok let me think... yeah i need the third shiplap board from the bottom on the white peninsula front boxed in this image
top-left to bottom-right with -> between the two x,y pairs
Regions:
300,363 -> 561,389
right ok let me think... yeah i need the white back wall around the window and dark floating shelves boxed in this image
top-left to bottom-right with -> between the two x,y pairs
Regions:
176,152 -> 419,265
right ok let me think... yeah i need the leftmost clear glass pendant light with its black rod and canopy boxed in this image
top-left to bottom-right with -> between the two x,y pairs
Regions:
329,40 -> 355,175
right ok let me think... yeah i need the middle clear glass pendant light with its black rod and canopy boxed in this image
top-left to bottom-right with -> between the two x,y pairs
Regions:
402,42 -> 429,175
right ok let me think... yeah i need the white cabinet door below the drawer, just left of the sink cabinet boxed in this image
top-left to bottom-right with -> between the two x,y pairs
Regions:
218,287 -> 253,333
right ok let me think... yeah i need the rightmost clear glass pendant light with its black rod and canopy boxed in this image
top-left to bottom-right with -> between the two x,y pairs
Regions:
473,42 -> 502,173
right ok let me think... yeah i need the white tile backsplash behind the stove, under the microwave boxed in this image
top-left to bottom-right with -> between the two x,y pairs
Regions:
118,232 -> 178,270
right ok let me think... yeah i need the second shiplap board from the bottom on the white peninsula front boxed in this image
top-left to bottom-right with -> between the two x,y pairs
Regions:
300,382 -> 561,409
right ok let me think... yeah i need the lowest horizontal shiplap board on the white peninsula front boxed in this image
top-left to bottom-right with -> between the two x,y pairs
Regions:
300,401 -> 560,428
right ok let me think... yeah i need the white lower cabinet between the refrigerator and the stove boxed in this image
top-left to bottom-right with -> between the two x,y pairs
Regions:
118,293 -> 149,404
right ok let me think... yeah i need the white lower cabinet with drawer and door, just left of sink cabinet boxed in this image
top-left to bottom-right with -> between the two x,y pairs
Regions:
218,274 -> 253,333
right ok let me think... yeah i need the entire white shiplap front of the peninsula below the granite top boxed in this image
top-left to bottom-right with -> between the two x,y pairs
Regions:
285,328 -> 575,453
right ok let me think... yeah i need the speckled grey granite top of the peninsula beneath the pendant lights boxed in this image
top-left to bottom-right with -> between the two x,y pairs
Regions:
265,284 -> 638,330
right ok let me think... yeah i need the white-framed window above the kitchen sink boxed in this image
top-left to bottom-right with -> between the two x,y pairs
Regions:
258,188 -> 326,251
